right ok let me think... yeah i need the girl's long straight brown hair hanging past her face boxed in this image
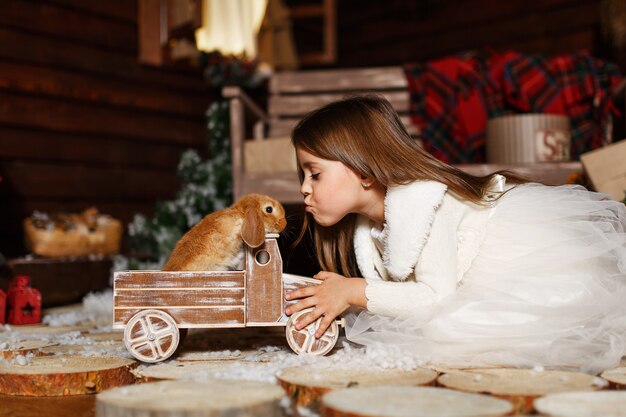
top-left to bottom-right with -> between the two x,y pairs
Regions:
292,95 -> 525,276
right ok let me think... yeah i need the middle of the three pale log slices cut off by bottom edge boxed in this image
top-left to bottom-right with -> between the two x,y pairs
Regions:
322,386 -> 513,417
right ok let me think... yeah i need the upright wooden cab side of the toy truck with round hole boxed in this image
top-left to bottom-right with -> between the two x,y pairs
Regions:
246,238 -> 284,326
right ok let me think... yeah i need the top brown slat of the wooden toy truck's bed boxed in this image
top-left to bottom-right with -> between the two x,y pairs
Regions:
113,271 -> 245,289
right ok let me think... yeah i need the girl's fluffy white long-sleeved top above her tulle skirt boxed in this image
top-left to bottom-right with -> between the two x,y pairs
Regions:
354,175 -> 505,317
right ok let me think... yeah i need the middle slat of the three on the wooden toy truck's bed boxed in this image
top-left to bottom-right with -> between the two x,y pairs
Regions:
113,288 -> 245,307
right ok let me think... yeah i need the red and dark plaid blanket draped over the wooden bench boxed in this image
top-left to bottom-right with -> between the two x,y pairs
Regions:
404,52 -> 621,163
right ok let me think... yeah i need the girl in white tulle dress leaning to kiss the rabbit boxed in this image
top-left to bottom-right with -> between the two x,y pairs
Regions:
286,96 -> 626,373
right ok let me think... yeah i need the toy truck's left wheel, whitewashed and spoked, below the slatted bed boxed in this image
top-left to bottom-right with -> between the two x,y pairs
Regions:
124,310 -> 180,363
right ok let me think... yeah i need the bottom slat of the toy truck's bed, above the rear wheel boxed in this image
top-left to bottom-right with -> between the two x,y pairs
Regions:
113,306 -> 245,328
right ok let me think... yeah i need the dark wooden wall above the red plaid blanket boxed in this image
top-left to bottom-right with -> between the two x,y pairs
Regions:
337,0 -> 608,70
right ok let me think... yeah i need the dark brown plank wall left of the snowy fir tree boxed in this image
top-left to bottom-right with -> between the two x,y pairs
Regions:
0,0 -> 210,256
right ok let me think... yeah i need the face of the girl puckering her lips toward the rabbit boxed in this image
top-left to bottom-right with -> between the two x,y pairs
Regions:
296,149 -> 364,226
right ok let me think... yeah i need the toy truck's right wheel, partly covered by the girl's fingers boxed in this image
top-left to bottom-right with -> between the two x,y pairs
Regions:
286,308 -> 339,356
